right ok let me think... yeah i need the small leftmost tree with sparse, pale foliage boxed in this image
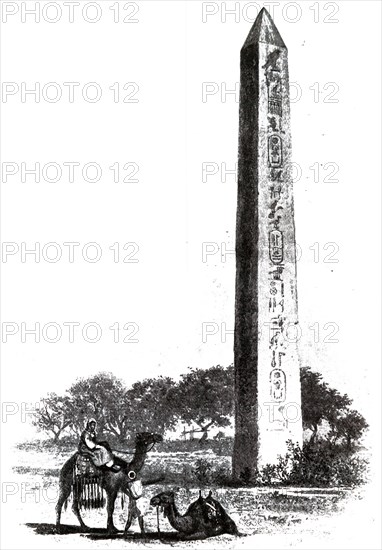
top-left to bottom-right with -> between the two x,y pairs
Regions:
32,393 -> 73,441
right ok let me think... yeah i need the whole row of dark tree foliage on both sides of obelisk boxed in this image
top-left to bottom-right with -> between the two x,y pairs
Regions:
33,365 -> 368,466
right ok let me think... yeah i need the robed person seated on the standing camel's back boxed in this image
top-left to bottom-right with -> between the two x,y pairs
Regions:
78,418 -> 121,472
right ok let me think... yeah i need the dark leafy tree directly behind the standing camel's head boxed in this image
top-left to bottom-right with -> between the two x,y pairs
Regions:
127,376 -> 176,433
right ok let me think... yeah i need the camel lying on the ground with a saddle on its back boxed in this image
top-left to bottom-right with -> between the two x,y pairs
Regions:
150,491 -> 239,540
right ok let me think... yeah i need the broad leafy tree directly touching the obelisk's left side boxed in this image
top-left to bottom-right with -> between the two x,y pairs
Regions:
171,365 -> 234,440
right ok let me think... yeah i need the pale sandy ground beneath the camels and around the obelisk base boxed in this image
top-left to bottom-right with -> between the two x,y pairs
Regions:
2,450 -> 377,549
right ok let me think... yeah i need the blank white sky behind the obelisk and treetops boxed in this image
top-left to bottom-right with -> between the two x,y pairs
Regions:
1,1 -> 380,450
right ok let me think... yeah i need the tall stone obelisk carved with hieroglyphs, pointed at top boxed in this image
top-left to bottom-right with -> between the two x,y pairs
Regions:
233,9 -> 302,481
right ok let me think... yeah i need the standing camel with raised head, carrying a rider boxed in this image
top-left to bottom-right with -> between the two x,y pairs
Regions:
56,432 -> 163,534
